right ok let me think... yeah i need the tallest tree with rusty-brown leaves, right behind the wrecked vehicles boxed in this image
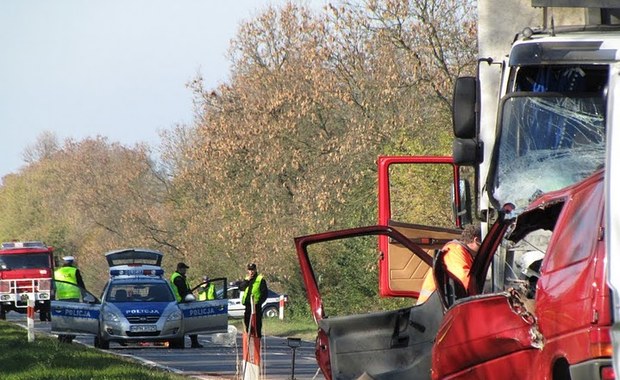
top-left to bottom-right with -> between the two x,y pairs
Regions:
178,1 -> 475,306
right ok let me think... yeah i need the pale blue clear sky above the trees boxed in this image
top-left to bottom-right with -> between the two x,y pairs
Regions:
0,0 -> 327,178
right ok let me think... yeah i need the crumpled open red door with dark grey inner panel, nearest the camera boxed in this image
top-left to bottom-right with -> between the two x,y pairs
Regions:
295,226 -> 442,379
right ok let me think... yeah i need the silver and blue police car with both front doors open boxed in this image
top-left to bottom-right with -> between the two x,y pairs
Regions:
51,249 -> 228,349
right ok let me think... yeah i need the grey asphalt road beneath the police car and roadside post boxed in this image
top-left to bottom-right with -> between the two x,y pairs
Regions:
7,312 -> 324,380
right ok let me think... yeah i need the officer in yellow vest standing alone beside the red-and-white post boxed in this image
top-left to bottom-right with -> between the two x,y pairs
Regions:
239,263 -> 267,338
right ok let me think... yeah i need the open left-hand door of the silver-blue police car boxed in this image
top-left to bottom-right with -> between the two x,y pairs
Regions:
51,281 -> 101,335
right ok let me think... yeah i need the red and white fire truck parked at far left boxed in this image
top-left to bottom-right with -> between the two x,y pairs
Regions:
0,241 -> 54,321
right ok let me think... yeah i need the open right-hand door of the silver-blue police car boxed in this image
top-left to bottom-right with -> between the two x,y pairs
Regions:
179,278 -> 228,334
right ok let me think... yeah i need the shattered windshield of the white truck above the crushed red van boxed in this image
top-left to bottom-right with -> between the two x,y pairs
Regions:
487,92 -> 605,211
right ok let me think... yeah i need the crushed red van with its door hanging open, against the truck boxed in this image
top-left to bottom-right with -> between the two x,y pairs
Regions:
295,170 -> 615,379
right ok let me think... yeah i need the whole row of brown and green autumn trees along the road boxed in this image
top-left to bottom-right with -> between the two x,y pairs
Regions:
0,0 -> 476,314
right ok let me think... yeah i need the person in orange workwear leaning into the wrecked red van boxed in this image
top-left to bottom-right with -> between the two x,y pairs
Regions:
417,224 -> 482,305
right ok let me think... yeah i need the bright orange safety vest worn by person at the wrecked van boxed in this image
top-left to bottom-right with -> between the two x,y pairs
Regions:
417,240 -> 474,304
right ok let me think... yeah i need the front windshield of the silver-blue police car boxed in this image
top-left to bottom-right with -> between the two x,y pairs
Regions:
106,282 -> 174,303
